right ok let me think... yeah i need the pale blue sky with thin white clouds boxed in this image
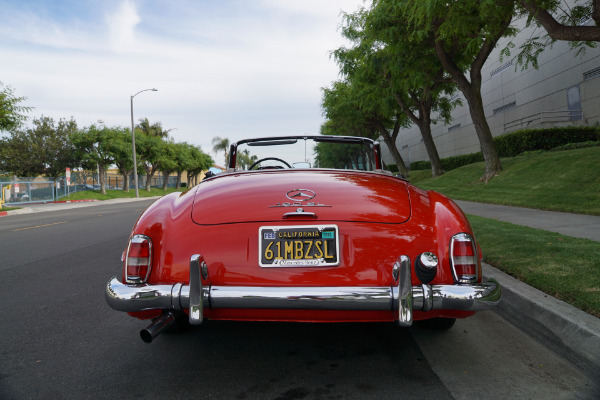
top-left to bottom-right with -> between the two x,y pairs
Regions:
0,0 -> 363,166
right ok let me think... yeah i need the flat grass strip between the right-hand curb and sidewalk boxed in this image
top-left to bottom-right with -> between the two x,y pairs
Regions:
468,215 -> 600,318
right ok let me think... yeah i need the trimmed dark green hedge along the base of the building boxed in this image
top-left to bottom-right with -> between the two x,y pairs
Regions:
410,126 -> 600,171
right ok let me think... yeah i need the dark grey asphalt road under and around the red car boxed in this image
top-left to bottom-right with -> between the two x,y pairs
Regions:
0,200 -> 599,400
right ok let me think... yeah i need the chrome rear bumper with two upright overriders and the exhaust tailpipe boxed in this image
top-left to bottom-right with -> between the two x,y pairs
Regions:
106,254 -> 502,342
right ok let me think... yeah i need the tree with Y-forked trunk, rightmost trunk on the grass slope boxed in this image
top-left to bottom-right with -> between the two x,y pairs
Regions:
398,0 -> 516,182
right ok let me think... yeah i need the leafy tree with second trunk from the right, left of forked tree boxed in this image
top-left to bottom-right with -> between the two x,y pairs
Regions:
334,3 -> 456,177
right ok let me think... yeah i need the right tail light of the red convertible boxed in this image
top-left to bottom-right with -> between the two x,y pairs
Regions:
450,233 -> 480,283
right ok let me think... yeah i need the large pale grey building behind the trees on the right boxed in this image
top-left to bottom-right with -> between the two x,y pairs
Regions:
382,13 -> 600,165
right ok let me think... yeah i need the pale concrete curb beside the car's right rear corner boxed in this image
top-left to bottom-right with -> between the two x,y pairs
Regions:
483,264 -> 600,381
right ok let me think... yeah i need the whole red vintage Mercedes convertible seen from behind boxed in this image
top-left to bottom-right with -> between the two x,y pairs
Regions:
106,136 -> 501,342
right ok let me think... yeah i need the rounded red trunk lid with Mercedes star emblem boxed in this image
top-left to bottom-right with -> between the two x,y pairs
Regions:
192,170 -> 410,225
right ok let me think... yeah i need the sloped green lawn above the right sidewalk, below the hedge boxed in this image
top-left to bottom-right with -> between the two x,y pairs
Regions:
409,147 -> 600,215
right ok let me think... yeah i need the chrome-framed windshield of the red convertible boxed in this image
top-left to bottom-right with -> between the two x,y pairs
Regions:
236,137 -> 375,171
